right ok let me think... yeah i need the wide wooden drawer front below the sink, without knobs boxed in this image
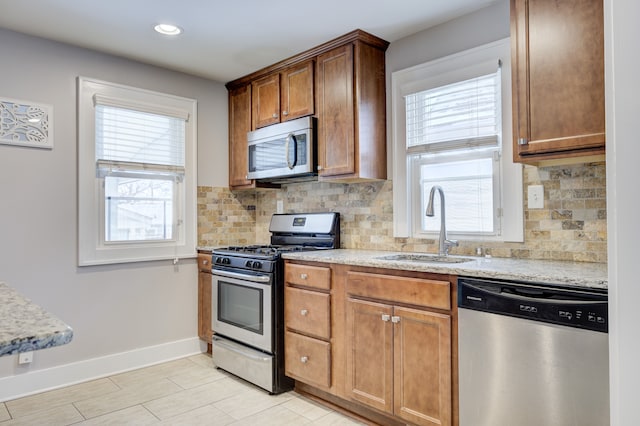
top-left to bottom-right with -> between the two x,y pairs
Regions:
347,272 -> 451,310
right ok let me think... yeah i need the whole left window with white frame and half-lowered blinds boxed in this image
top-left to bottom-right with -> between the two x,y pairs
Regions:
78,78 -> 196,265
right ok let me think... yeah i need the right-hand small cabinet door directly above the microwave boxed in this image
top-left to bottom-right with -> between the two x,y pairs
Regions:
280,61 -> 314,121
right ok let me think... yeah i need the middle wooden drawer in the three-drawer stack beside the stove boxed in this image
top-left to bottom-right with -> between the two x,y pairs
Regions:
284,287 -> 331,339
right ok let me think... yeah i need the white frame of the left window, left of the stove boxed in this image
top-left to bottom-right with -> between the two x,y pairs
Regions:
78,77 -> 197,266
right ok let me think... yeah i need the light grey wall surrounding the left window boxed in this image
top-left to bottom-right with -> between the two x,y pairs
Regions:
0,29 -> 228,400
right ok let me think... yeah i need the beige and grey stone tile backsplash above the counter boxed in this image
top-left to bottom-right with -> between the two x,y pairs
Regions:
198,162 -> 607,263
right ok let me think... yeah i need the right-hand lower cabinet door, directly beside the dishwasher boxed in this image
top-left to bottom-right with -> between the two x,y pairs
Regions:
393,307 -> 451,425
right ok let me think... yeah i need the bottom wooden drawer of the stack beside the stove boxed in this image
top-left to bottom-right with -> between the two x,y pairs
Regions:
284,331 -> 331,388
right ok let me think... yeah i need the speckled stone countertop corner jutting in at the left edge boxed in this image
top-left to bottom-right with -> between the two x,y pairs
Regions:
0,282 -> 73,356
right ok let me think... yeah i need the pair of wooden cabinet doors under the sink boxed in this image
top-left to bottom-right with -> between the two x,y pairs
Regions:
346,298 -> 451,425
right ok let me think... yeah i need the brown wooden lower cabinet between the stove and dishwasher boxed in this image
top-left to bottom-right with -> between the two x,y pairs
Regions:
285,261 -> 458,425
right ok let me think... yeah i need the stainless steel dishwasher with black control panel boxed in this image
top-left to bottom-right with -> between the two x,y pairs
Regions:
458,278 -> 609,426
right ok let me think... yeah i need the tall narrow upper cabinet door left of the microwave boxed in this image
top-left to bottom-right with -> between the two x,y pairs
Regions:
229,85 -> 253,189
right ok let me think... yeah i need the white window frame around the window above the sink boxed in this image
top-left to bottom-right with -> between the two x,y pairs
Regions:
391,39 -> 524,242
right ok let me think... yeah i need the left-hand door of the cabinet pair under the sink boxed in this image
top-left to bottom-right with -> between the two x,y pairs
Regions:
345,298 -> 393,413
